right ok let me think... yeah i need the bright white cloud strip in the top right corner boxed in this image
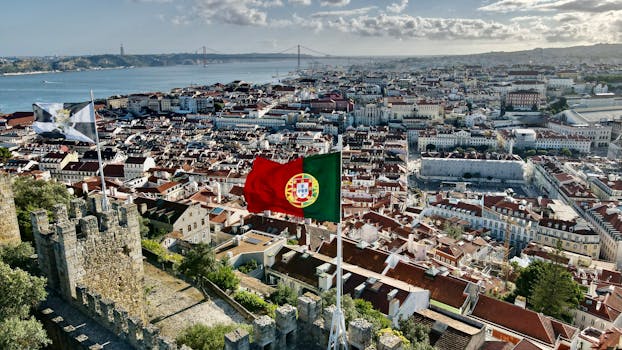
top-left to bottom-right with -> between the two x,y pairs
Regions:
478,0 -> 622,13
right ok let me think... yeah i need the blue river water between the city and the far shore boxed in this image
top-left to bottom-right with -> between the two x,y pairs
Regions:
0,59 -> 352,113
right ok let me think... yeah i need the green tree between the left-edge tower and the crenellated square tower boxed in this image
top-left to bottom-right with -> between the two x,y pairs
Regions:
13,177 -> 72,241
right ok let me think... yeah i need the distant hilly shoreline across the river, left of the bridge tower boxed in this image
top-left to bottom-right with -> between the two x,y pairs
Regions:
0,53 -> 311,74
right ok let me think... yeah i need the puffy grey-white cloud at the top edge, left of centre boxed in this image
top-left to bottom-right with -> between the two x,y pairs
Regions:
194,0 -> 268,26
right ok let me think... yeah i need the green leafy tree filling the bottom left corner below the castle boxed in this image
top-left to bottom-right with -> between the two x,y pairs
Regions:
0,261 -> 50,350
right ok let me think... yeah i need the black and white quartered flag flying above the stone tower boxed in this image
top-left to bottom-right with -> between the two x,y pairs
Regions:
32,102 -> 96,143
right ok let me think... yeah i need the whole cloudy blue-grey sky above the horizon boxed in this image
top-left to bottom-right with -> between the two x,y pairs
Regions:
0,0 -> 622,57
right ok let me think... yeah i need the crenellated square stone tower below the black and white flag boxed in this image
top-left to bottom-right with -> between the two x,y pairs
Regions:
31,196 -> 145,320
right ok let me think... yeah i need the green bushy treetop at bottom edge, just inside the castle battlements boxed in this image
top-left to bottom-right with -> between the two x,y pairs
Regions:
175,323 -> 252,350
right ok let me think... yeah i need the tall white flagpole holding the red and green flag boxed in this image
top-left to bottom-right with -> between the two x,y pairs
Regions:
328,144 -> 348,350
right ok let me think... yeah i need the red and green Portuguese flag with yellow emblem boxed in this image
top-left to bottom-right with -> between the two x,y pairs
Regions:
244,153 -> 341,222
